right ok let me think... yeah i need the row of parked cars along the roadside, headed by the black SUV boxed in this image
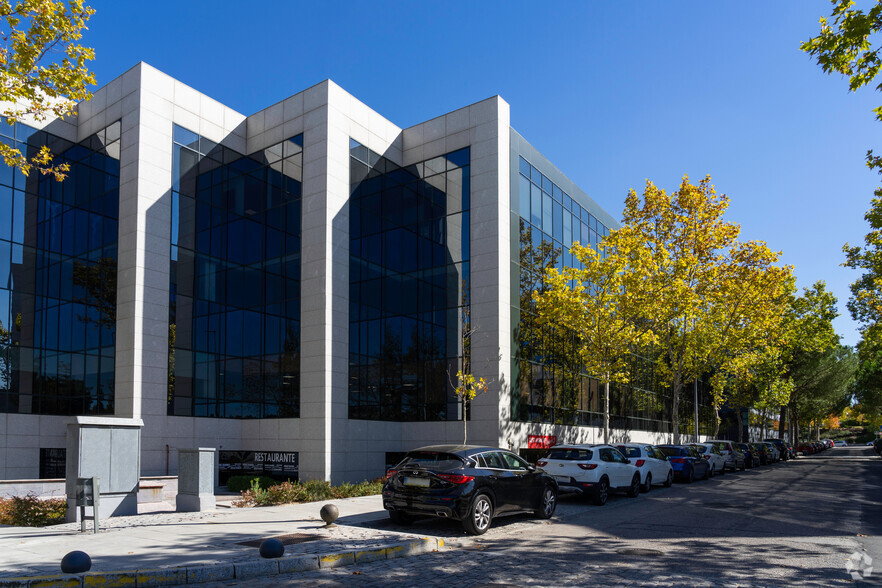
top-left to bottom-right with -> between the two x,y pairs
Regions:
383,439 -> 796,535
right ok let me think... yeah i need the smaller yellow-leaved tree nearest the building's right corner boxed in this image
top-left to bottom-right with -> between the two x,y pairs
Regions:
533,230 -> 654,443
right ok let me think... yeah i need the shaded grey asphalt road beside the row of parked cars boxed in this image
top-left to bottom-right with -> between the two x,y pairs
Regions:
205,447 -> 882,587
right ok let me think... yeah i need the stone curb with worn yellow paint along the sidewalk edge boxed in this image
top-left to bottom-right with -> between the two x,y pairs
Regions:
0,537 -> 451,588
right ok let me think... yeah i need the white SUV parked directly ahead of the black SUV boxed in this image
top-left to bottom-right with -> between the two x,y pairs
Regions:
536,445 -> 640,505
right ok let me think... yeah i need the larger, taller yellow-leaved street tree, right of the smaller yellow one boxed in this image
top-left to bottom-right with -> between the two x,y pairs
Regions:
621,177 -> 793,443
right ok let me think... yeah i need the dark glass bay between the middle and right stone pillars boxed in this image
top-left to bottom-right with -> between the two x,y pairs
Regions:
349,141 -> 470,421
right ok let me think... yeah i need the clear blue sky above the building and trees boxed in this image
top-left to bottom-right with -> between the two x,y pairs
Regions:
84,0 -> 882,344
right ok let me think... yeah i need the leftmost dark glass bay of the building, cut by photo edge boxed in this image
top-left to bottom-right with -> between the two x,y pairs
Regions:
0,122 -> 120,415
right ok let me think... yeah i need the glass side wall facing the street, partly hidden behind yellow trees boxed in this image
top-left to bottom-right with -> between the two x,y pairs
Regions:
512,157 -> 714,433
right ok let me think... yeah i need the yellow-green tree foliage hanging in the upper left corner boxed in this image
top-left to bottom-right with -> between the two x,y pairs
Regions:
0,0 -> 95,180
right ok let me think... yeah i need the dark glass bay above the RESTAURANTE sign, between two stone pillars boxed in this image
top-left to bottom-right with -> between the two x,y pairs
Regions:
168,126 -> 303,418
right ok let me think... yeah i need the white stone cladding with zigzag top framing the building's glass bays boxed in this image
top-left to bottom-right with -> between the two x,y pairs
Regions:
0,63 -> 672,482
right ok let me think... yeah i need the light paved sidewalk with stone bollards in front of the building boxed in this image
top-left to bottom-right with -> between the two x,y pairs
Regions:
0,496 -> 457,587
